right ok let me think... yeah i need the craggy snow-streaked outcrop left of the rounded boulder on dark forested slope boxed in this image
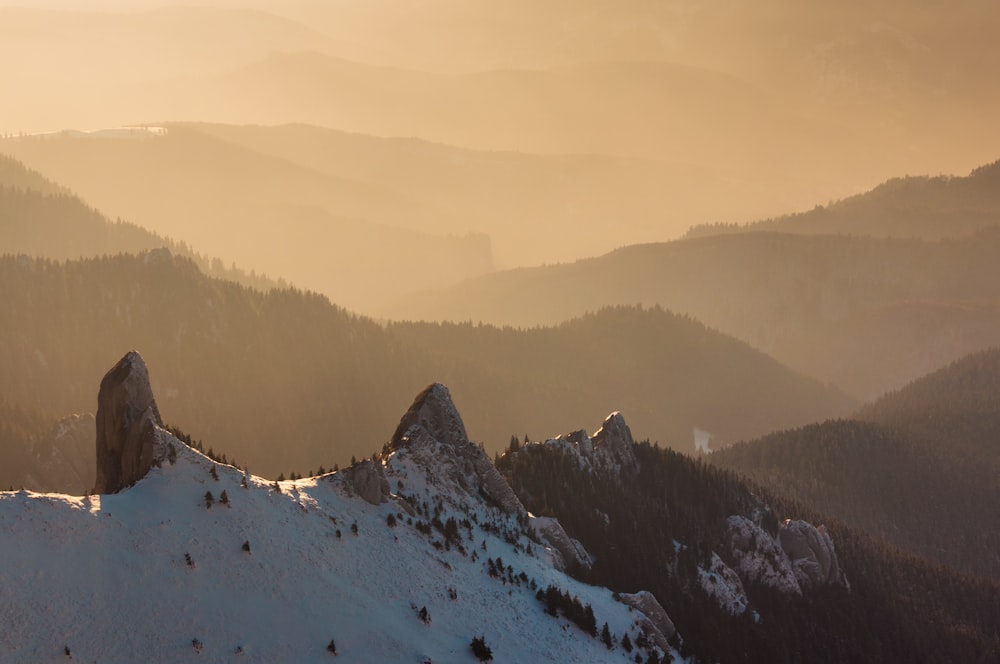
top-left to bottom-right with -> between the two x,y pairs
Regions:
726,516 -> 802,594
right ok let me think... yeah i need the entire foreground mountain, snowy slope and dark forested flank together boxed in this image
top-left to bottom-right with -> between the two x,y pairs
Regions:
0,351 -> 1000,663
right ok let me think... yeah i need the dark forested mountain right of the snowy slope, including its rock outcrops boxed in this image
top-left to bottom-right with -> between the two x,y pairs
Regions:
497,408 -> 1000,663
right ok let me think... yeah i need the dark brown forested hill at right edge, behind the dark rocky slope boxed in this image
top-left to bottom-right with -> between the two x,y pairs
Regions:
709,420 -> 1000,579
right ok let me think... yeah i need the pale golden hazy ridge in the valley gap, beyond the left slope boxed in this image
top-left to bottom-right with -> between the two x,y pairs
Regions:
176,124 -> 771,267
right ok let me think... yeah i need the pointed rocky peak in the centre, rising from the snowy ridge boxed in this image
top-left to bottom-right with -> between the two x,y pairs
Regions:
392,383 -> 527,516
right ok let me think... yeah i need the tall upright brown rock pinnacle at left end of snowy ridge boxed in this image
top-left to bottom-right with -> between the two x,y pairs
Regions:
94,351 -> 163,493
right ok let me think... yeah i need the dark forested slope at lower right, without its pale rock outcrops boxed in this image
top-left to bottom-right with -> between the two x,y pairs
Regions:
499,443 -> 1000,663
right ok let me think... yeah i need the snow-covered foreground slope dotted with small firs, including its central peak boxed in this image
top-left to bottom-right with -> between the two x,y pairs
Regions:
0,353 -> 679,662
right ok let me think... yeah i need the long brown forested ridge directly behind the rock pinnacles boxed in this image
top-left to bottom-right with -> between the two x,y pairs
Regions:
0,251 -> 856,486
